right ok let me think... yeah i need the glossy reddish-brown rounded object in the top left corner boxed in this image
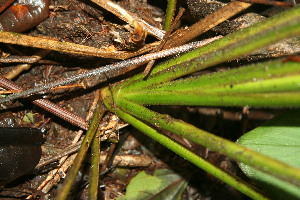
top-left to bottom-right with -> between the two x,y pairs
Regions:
0,0 -> 50,32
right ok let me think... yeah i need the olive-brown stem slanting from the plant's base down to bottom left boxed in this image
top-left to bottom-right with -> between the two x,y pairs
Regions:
55,101 -> 105,200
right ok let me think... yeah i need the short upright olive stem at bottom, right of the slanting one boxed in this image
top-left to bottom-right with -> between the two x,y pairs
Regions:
88,135 -> 101,200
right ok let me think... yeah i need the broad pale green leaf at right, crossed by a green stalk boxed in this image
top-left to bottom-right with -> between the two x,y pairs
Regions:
237,110 -> 300,199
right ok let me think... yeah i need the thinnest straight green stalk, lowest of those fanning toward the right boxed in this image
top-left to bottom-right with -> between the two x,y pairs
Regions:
116,106 -> 268,199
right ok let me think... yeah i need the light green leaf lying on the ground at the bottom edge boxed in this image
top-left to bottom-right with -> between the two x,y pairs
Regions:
120,169 -> 187,200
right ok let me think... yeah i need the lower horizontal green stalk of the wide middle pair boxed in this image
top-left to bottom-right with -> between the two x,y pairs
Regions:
121,91 -> 300,108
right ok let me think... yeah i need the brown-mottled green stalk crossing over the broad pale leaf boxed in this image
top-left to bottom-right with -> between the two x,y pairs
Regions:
112,99 -> 300,186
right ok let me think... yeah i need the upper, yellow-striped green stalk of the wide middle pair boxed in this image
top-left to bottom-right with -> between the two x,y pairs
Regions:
139,59 -> 300,92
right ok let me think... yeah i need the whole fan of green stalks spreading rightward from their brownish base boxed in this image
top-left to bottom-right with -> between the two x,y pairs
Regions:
102,6 -> 300,199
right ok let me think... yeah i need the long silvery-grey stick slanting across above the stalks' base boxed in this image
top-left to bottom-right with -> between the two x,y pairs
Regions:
0,36 -> 220,104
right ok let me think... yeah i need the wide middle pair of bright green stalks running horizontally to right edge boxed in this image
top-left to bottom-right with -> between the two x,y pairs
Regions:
117,60 -> 300,107
